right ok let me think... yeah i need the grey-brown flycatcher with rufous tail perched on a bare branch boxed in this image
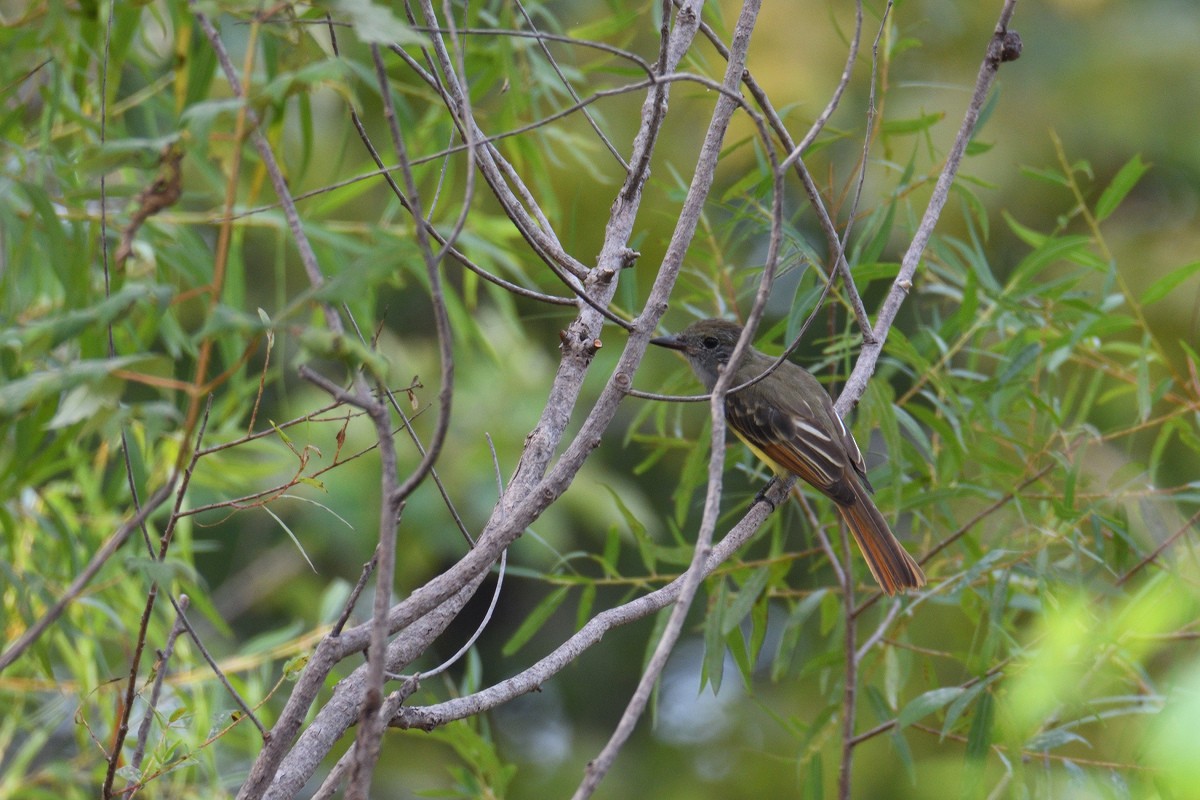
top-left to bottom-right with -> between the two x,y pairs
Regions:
652,319 -> 925,595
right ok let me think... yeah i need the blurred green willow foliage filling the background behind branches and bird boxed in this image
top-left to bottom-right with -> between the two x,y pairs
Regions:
0,0 -> 1200,799
